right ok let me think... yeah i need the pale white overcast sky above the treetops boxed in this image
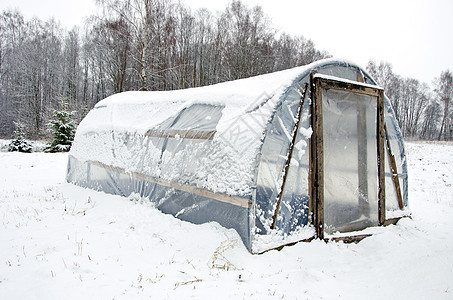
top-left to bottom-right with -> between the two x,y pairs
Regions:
0,0 -> 453,83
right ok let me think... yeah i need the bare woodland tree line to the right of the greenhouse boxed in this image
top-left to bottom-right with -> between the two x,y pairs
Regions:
367,61 -> 453,140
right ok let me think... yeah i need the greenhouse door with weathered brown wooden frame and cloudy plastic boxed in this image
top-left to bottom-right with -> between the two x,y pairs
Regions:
311,75 -> 385,238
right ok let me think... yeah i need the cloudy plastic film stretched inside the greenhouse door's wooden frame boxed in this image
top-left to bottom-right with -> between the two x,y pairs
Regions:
322,89 -> 378,233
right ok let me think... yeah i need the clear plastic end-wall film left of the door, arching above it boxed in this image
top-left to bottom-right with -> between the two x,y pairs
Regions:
255,62 -> 384,241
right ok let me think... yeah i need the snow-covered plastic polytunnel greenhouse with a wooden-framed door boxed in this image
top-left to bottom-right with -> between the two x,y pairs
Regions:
66,59 -> 409,253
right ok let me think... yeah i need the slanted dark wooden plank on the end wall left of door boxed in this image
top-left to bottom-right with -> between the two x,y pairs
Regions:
271,84 -> 308,229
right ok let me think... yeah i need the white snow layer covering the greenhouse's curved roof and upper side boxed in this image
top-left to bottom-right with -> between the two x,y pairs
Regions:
71,59 -> 368,196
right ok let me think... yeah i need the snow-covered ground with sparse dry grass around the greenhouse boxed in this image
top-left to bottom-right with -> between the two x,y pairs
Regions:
0,142 -> 453,299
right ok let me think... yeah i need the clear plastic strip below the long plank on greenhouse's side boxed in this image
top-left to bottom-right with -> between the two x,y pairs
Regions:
67,156 -> 250,246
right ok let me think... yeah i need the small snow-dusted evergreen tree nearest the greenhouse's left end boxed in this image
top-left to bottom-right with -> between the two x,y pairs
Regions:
44,102 -> 75,152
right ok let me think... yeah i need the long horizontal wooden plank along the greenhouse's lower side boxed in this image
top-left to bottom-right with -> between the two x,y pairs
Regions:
87,161 -> 252,208
